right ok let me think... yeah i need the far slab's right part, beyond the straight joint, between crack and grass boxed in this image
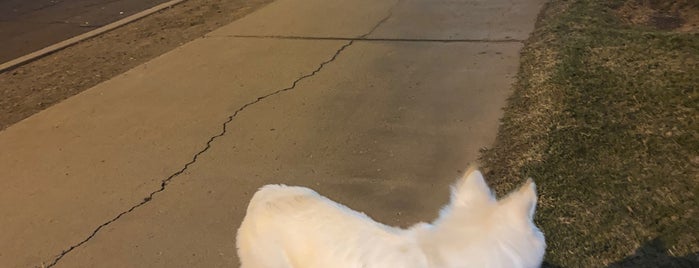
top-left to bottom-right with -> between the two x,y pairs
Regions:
369,0 -> 545,40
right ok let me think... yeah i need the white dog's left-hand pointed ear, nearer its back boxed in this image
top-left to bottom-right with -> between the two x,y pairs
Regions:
452,167 -> 495,206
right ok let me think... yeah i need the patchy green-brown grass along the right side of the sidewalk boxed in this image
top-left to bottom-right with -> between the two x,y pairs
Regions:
482,0 -> 699,267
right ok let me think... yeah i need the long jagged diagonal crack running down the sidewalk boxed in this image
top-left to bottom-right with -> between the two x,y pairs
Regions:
41,0 -> 400,268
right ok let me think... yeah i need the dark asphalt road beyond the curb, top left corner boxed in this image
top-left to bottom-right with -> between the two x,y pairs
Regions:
0,0 -> 167,63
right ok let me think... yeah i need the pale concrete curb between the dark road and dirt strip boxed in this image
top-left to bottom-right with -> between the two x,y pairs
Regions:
0,0 -> 187,73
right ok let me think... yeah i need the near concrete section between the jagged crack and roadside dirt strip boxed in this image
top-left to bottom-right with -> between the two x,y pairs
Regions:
0,39 -> 348,267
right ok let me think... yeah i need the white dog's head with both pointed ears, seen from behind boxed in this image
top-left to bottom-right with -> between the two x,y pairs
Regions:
426,168 -> 546,267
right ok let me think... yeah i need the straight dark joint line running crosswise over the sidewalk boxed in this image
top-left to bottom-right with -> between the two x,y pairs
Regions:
217,35 -> 525,43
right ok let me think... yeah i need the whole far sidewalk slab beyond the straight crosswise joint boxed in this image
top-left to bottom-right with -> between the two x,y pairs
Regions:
209,0 -> 545,41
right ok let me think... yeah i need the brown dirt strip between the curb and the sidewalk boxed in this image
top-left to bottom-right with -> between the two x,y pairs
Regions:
0,0 -> 272,130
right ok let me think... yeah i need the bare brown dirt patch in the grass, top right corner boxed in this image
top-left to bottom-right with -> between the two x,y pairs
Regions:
617,0 -> 699,33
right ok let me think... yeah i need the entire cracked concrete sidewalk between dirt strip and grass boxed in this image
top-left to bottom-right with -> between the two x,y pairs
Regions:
0,0 -> 544,267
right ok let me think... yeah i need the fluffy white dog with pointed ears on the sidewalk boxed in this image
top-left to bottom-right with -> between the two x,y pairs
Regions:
237,168 -> 546,268
